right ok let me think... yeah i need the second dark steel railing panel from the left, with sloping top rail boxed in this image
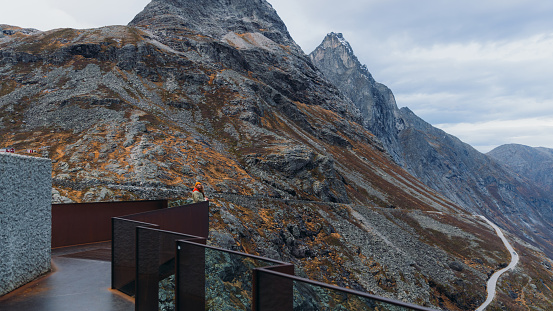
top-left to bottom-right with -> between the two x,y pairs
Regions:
135,227 -> 206,311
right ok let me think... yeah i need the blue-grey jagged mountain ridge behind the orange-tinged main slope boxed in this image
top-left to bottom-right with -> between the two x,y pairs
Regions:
310,33 -> 553,310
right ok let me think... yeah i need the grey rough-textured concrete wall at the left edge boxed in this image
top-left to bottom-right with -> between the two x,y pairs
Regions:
0,153 -> 52,296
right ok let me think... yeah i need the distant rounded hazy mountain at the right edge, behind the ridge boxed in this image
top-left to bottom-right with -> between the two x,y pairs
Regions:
487,144 -> 553,192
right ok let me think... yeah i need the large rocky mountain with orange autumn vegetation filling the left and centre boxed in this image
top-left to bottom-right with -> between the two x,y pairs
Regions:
0,0 -> 553,310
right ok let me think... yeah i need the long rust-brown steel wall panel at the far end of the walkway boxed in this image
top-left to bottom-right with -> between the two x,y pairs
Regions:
51,200 -> 167,248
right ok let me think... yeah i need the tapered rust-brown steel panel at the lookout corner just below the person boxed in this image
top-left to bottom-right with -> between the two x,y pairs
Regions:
123,202 -> 209,238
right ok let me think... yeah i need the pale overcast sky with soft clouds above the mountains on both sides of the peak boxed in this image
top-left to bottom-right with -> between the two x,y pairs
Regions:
0,0 -> 553,152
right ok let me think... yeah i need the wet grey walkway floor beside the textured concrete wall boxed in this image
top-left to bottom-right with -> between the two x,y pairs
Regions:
0,243 -> 134,311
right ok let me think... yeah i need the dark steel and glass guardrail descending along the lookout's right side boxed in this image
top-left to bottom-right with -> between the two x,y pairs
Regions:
112,202 -> 433,311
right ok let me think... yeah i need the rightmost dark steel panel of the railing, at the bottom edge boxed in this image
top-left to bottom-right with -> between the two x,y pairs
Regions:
252,264 -> 294,311
